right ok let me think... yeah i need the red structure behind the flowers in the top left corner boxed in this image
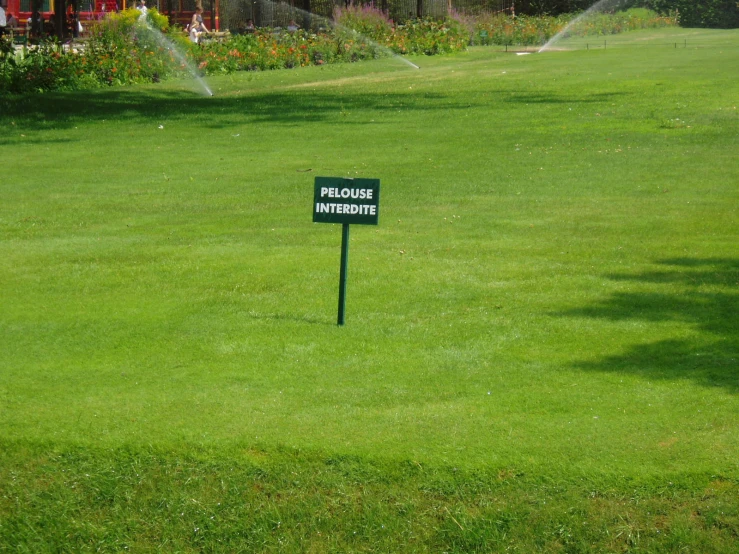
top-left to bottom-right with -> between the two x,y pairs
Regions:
6,0 -> 220,38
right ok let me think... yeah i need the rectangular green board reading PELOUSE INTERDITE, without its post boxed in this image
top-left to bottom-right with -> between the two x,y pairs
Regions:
313,177 -> 380,225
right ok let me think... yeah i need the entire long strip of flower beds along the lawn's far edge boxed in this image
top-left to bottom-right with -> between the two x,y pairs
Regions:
0,5 -> 677,93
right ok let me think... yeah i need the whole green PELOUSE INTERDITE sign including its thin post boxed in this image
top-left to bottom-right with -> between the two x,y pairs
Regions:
313,177 -> 380,325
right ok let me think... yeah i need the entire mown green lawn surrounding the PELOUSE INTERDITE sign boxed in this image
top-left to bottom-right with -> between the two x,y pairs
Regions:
0,30 -> 739,553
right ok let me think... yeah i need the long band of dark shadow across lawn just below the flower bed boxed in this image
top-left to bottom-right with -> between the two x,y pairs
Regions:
0,83 -> 632,135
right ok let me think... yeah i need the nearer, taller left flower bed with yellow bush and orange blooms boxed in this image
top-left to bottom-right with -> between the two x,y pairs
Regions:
0,10 -> 468,92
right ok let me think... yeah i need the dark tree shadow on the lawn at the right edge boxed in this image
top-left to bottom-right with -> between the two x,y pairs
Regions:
560,258 -> 739,393
